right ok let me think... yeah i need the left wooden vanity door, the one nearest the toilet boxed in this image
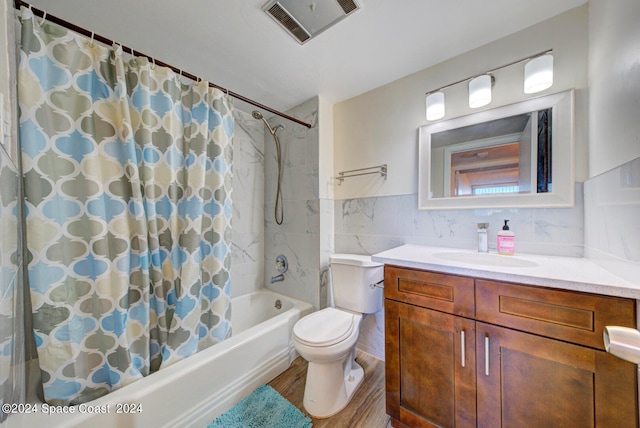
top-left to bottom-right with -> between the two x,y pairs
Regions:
385,299 -> 476,427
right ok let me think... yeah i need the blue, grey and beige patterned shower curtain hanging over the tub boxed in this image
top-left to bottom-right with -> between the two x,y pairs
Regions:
18,9 -> 234,404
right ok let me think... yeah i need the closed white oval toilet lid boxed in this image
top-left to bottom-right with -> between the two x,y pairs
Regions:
293,308 -> 354,346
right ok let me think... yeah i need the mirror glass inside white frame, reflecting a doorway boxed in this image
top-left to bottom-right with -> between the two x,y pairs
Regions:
431,108 -> 552,198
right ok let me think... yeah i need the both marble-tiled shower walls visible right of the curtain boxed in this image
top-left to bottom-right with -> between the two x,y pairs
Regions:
231,98 -> 334,308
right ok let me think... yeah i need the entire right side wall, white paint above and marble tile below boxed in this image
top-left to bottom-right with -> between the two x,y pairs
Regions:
585,0 -> 640,283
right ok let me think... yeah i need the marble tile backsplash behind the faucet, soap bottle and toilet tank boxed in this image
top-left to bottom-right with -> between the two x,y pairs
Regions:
334,183 -> 584,257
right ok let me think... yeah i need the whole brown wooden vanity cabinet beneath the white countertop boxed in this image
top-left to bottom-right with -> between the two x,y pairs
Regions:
385,265 -> 638,428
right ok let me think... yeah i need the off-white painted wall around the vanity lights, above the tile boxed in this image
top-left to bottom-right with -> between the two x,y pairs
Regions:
334,6 -> 588,199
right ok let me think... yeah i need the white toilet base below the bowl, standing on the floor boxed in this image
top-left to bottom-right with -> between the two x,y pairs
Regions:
303,357 -> 364,419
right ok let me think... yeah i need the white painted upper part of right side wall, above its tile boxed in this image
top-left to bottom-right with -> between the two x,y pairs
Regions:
589,0 -> 640,177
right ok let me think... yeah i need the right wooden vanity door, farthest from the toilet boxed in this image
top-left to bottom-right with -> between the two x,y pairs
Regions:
476,322 -> 638,428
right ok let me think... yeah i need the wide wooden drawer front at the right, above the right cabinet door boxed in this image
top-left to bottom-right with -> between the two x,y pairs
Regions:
476,280 -> 636,349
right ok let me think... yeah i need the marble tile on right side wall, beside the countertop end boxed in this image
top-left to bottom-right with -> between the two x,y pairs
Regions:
584,158 -> 640,284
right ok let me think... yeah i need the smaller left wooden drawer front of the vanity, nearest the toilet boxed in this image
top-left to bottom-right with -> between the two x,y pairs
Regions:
384,265 -> 475,318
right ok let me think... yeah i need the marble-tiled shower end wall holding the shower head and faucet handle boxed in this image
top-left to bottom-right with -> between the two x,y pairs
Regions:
264,98 -> 327,308
